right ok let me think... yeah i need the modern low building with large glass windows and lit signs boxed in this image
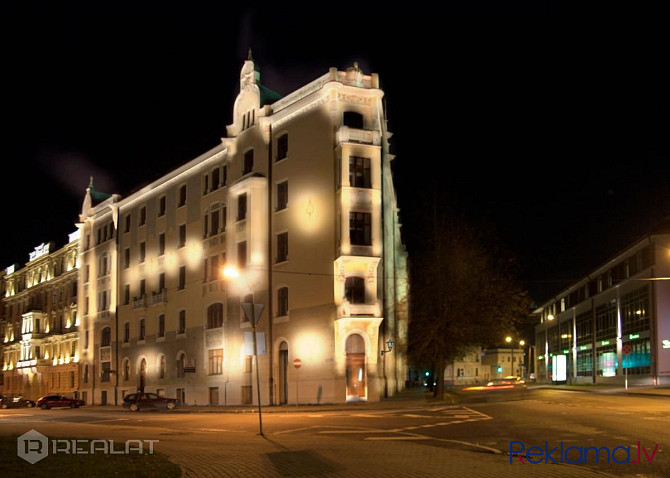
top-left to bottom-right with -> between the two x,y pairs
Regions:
533,221 -> 670,385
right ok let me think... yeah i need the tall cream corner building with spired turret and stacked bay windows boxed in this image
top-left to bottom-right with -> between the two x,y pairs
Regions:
79,58 -> 408,405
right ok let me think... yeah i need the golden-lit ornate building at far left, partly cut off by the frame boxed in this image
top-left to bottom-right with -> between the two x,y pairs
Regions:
0,238 -> 80,400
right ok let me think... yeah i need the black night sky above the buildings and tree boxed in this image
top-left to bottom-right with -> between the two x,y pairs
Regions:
0,1 -> 670,302
